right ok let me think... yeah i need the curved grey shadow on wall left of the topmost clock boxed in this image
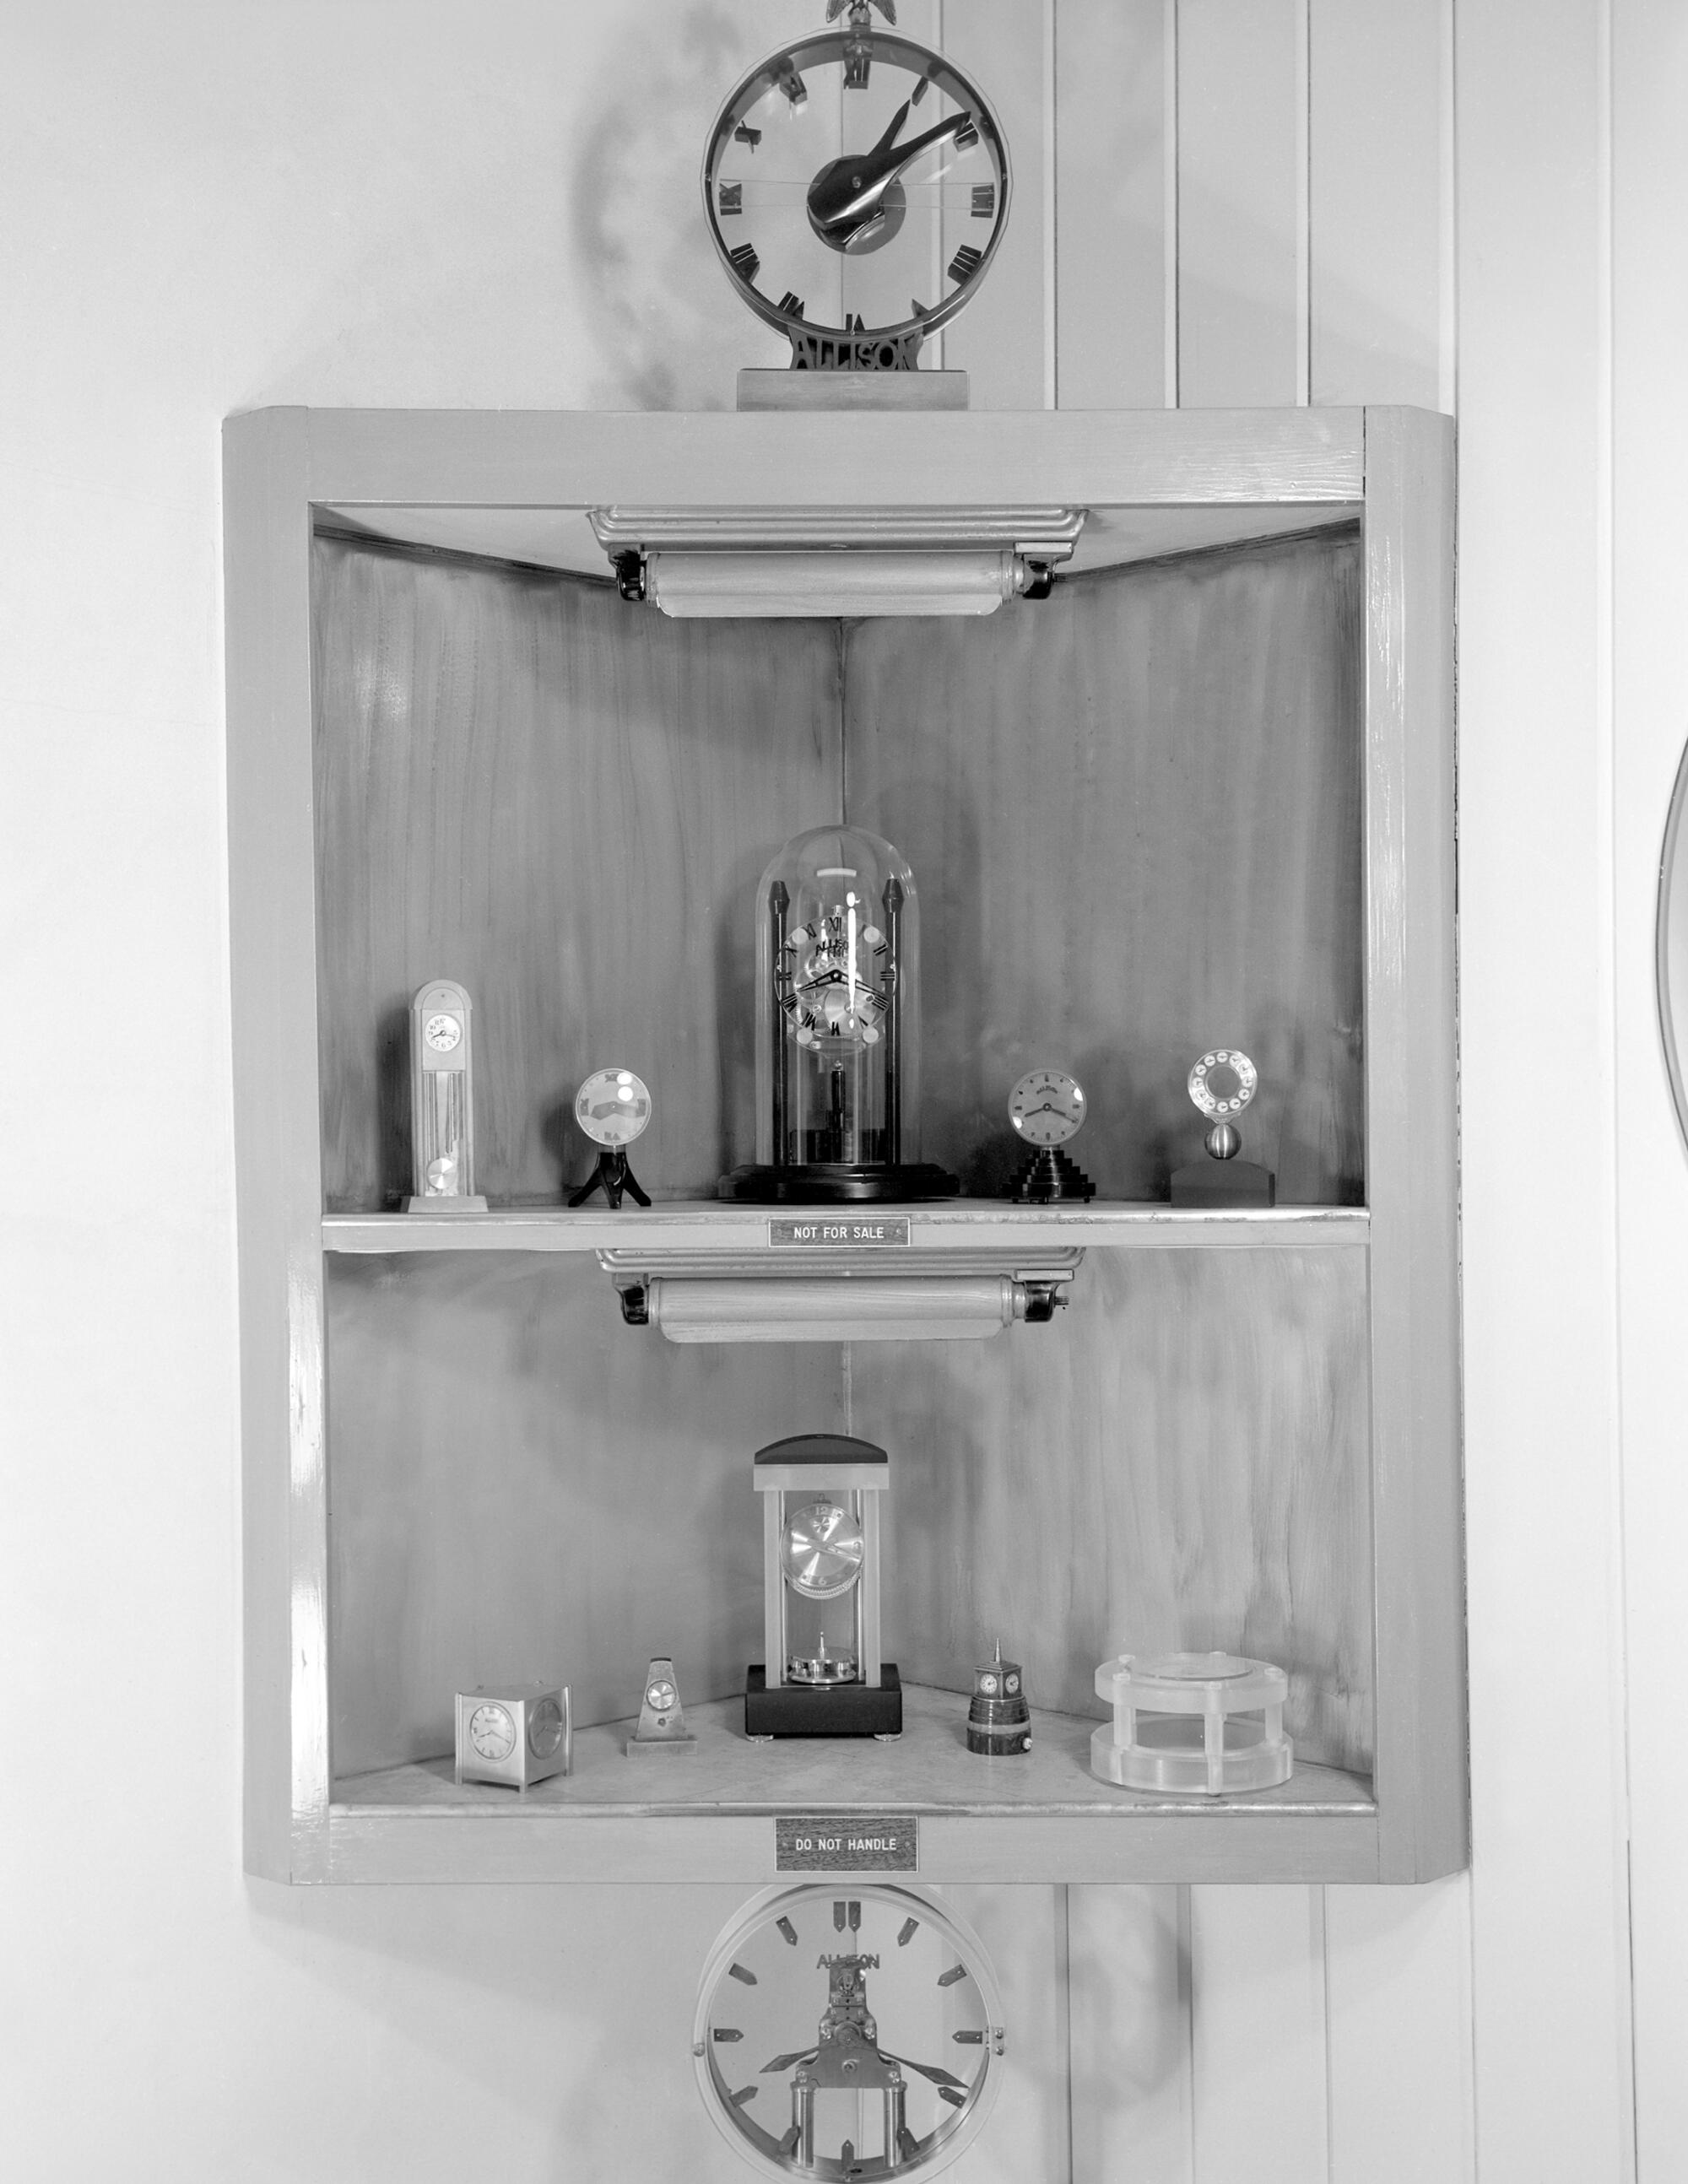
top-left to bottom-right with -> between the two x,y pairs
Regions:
570,0 -> 794,411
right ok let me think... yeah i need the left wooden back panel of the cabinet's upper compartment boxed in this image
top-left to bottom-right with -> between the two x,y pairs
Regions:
312,538 -> 841,1212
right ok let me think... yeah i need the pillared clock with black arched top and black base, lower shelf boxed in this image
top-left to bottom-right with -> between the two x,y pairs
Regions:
744,1433 -> 902,1736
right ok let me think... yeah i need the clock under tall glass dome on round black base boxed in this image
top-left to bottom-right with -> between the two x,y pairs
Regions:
721,825 -> 960,1203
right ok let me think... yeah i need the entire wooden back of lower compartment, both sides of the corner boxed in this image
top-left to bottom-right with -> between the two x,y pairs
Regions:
327,1247 -> 1372,1773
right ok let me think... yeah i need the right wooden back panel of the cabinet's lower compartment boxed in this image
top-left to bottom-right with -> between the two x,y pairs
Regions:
849,1247 -> 1373,1773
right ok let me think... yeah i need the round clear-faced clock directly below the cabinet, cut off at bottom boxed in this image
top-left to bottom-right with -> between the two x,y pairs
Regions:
692,1880 -> 1004,2180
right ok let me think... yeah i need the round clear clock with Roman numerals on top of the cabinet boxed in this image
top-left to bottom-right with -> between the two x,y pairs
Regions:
703,4 -> 1009,369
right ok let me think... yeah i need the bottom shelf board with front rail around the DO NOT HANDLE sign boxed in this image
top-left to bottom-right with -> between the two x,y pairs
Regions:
323,1684 -> 1378,1884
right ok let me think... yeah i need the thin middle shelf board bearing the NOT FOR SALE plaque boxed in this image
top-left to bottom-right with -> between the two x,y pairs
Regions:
323,1199 -> 1372,1258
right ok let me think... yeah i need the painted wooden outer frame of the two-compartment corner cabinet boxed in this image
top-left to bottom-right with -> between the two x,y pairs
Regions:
225,408 -> 1468,1883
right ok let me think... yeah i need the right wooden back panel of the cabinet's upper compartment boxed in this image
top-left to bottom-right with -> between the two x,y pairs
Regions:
845,527 -> 1365,1206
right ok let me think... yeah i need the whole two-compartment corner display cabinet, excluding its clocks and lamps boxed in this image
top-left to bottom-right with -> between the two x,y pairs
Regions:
227,408 -> 1465,1884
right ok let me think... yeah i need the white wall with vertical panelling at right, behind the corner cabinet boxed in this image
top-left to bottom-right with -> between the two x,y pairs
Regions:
0,0 -> 1642,2184
